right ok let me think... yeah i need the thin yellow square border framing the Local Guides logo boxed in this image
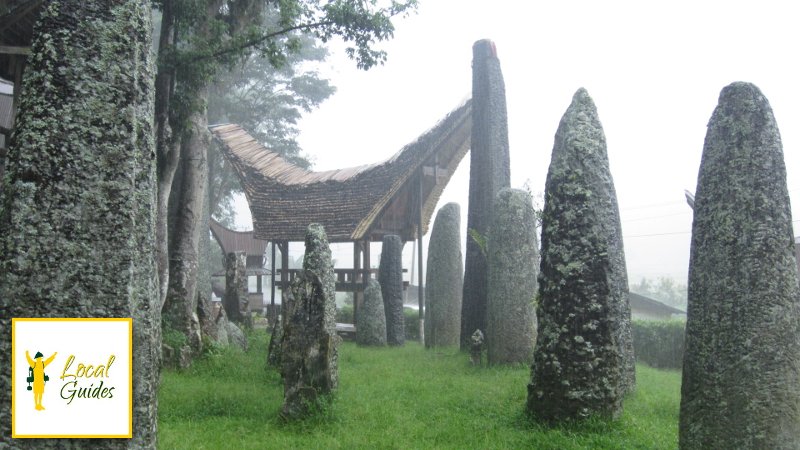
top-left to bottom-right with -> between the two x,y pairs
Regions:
11,317 -> 133,439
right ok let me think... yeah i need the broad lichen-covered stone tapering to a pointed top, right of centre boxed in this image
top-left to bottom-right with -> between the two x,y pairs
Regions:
527,89 -> 635,421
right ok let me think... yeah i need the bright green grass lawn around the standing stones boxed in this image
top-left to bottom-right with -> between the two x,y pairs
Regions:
158,331 -> 680,450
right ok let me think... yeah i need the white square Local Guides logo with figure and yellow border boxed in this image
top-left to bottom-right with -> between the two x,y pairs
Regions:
11,318 -> 133,438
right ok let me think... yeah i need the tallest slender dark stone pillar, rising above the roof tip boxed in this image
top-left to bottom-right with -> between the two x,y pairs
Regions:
461,39 -> 511,350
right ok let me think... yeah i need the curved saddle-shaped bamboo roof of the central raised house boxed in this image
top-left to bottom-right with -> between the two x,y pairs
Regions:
210,100 -> 472,241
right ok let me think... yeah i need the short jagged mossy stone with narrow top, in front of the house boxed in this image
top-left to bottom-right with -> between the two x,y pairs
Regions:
281,224 -> 340,419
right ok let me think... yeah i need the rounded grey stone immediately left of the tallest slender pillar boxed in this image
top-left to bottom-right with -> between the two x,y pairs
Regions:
424,203 -> 464,347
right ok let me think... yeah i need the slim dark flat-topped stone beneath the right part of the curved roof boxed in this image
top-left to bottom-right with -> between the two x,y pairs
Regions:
378,234 -> 406,345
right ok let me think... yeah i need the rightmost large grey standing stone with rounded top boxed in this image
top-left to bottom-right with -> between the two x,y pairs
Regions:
679,82 -> 800,449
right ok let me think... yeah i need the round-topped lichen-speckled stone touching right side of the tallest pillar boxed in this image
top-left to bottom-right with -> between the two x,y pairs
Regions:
486,189 -> 539,364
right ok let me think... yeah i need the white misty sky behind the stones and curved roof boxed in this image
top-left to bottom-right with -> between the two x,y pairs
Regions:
231,0 -> 800,310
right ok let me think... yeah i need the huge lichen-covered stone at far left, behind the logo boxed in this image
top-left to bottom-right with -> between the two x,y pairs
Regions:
0,0 -> 161,449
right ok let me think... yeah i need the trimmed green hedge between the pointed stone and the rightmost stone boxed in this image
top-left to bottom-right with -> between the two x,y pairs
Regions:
631,320 -> 686,369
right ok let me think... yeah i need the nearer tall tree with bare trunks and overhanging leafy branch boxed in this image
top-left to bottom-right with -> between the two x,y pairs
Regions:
154,0 -> 417,366
